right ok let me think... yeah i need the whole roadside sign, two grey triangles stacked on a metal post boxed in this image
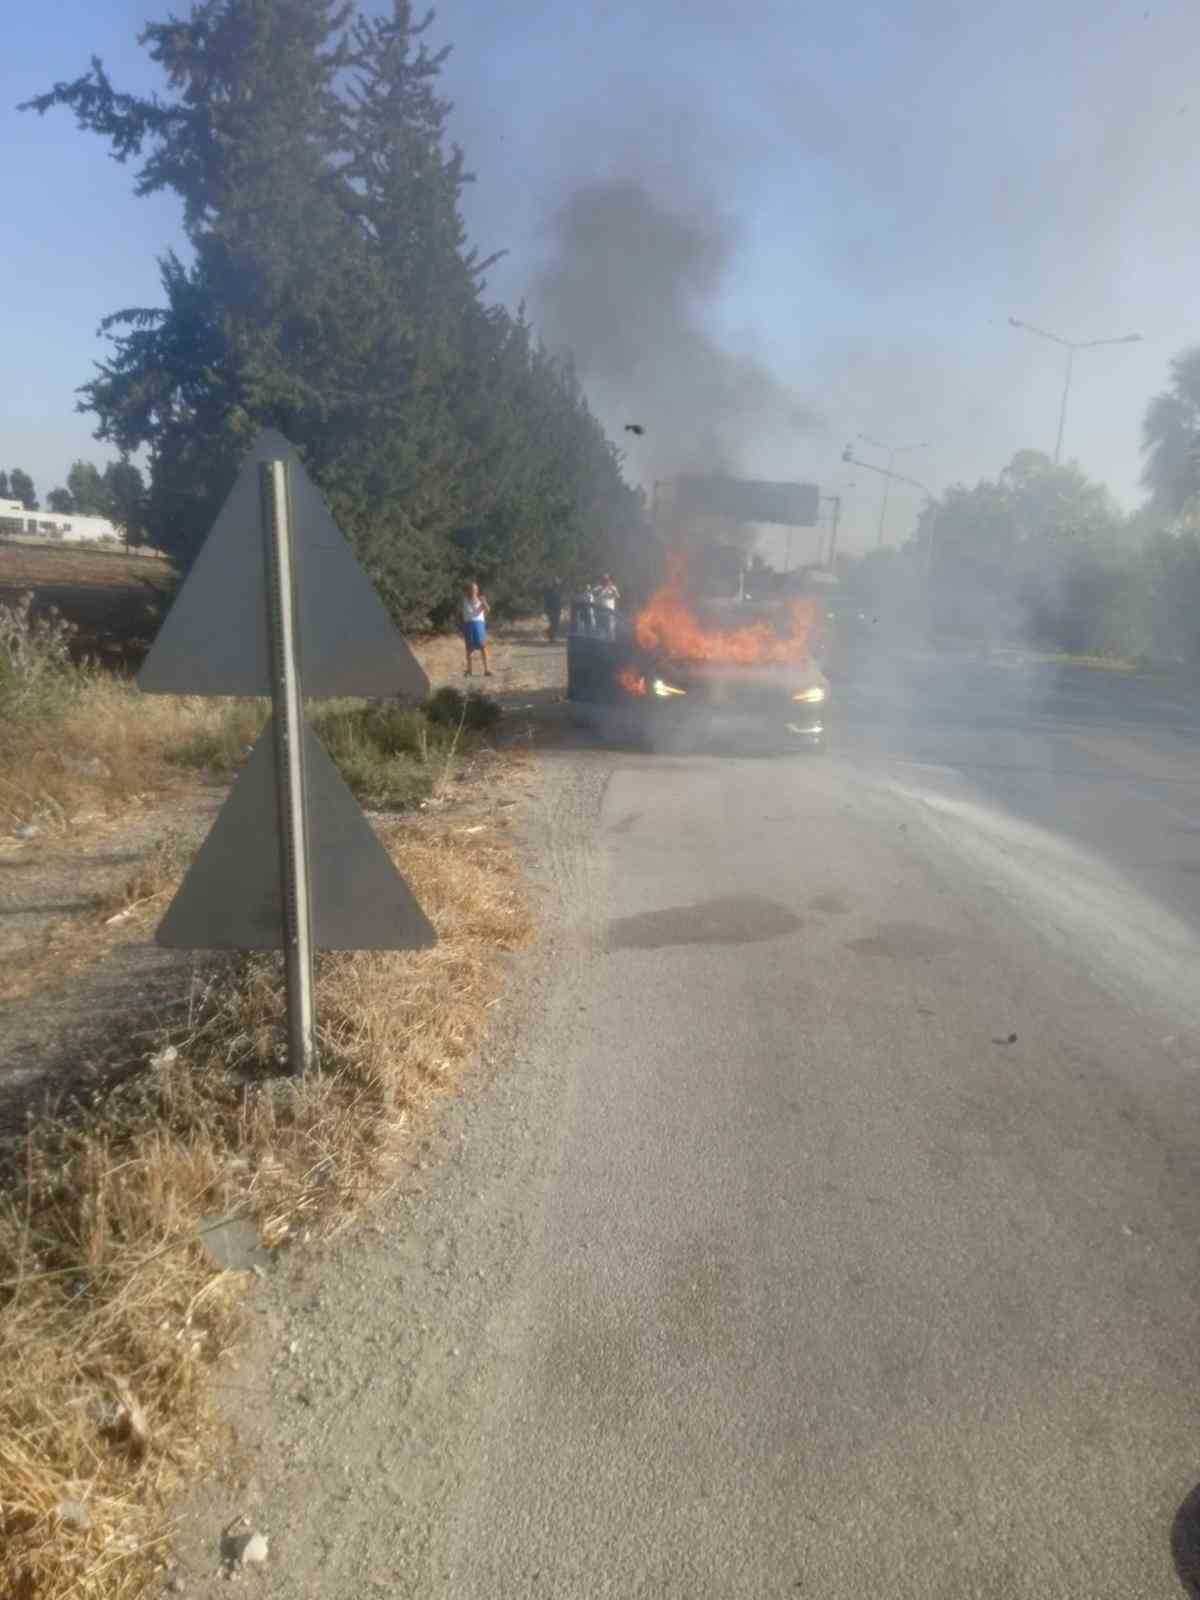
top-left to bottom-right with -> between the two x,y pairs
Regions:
138,432 -> 435,1072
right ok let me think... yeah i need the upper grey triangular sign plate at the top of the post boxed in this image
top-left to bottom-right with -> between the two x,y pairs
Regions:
138,429 -> 429,699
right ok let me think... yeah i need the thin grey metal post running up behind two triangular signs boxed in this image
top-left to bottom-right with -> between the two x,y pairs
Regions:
259,461 -> 317,1072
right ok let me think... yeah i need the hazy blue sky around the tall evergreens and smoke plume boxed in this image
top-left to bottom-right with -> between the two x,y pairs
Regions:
0,0 -> 1200,547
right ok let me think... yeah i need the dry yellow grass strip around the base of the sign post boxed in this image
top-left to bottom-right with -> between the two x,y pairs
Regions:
0,827 -> 528,1600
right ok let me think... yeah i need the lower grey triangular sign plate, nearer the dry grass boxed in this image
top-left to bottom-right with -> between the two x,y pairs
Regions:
155,723 -> 437,950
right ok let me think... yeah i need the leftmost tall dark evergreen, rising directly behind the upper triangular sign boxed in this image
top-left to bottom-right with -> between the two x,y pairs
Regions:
30,0 -> 370,560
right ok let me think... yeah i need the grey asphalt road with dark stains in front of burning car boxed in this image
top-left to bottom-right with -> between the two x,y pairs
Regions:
438,661 -> 1200,1600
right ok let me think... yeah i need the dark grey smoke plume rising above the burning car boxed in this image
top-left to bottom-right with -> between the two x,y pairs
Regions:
533,176 -> 824,480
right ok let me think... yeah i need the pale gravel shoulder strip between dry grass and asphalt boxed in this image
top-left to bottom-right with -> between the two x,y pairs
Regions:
171,742 -> 610,1600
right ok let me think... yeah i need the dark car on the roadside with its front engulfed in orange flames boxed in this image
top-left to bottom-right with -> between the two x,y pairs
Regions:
566,550 -> 829,749
